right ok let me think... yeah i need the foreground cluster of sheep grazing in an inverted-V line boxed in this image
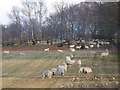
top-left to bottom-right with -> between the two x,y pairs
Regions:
42,54 -> 92,78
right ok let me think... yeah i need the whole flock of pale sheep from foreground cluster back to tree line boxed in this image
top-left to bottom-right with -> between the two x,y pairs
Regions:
42,41 -> 109,78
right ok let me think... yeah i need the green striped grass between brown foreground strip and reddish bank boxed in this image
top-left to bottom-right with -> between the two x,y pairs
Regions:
3,50 -> 118,77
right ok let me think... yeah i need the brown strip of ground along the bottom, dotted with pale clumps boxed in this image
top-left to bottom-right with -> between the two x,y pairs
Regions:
3,77 -> 118,88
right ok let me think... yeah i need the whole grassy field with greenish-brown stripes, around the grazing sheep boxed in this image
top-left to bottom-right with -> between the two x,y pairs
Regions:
2,50 -> 119,88
